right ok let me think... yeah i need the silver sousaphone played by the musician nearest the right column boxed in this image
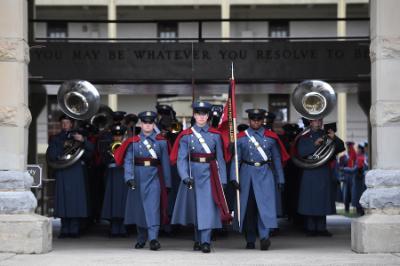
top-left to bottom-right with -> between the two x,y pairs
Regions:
292,80 -> 336,169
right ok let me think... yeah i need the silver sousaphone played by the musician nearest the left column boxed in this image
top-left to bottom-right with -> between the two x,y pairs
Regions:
46,80 -> 100,169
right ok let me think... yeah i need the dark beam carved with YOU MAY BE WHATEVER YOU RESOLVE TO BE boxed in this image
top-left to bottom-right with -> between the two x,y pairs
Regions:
29,41 -> 370,83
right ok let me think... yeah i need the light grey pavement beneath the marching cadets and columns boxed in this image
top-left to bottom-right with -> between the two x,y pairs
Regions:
0,215 -> 400,266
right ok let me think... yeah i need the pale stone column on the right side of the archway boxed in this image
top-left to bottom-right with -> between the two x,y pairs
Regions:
351,0 -> 400,253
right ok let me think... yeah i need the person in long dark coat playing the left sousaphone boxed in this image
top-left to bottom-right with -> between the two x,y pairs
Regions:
47,115 -> 94,238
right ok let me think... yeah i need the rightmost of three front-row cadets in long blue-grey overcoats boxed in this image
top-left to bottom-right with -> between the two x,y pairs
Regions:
230,109 -> 287,250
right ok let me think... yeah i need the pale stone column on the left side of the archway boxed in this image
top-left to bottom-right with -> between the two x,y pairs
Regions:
0,0 -> 52,253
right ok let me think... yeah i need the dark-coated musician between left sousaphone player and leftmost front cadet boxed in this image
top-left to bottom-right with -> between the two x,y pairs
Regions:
101,124 -> 128,237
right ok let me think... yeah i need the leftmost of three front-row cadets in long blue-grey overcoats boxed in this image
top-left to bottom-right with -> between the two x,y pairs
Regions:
114,111 -> 171,250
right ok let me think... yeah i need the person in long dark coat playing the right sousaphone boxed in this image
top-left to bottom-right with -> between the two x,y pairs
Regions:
297,119 -> 344,237
